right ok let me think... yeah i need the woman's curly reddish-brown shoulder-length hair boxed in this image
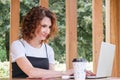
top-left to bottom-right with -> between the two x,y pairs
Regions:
21,6 -> 57,42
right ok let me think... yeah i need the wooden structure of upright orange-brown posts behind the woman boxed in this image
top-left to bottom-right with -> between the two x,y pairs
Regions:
10,0 -> 120,77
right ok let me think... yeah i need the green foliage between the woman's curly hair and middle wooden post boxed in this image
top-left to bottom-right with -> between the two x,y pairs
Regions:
49,0 -> 66,63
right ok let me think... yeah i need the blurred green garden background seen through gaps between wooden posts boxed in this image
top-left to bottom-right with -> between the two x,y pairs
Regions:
0,0 -> 105,77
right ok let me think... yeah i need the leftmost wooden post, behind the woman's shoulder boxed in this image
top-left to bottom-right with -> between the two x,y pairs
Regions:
10,0 -> 20,80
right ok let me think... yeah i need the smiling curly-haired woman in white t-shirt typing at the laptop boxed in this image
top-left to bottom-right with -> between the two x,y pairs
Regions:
11,6 -> 94,78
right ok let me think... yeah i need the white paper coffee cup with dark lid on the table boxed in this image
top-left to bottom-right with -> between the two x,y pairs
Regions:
73,58 -> 87,80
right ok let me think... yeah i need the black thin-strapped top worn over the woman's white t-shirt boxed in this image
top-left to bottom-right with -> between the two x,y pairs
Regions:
12,41 -> 49,78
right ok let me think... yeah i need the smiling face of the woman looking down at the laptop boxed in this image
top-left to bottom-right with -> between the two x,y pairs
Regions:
35,17 -> 51,40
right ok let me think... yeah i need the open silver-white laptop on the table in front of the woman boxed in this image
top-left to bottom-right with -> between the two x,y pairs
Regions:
86,42 -> 115,79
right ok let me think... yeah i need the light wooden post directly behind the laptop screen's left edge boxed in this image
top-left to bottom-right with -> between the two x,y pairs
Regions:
92,0 -> 103,72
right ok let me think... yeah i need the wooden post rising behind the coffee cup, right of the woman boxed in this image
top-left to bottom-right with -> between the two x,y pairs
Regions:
66,0 -> 77,69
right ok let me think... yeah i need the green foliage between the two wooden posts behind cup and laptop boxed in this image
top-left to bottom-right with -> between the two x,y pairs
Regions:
77,0 -> 92,61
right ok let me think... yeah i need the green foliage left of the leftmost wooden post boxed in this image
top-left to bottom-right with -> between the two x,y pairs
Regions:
0,0 -> 10,61
